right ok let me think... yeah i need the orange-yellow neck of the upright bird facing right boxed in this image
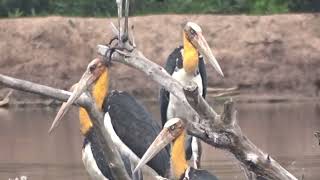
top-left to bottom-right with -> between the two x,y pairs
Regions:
183,33 -> 199,74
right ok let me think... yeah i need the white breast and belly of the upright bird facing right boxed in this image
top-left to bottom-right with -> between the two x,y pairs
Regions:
167,69 -> 203,119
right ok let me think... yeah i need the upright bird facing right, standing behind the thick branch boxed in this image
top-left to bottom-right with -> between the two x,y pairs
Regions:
160,22 -> 223,168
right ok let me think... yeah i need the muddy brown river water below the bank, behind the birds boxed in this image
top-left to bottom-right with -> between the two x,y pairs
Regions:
0,102 -> 320,180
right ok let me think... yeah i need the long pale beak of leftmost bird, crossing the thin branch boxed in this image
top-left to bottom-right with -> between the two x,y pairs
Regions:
49,71 -> 96,133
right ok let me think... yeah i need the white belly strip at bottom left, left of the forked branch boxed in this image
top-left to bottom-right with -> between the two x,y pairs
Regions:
82,142 -> 108,180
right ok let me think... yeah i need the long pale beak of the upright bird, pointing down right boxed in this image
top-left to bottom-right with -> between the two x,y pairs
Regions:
192,33 -> 224,77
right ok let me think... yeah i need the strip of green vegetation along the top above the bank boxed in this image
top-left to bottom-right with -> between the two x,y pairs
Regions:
0,0 -> 320,17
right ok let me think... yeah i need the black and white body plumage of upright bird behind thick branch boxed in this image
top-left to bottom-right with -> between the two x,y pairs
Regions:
160,46 -> 208,166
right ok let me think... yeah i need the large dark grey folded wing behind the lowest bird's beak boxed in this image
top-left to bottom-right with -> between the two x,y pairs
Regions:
103,91 -> 170,176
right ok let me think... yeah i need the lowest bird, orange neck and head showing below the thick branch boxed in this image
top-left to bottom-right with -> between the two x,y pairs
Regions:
135,118 -> 218,180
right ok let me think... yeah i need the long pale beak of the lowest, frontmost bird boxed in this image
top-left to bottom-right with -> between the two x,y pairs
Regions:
134,128 -> 174,172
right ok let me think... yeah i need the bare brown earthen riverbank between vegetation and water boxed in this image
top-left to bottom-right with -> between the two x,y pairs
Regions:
0,14 -> 320,105
